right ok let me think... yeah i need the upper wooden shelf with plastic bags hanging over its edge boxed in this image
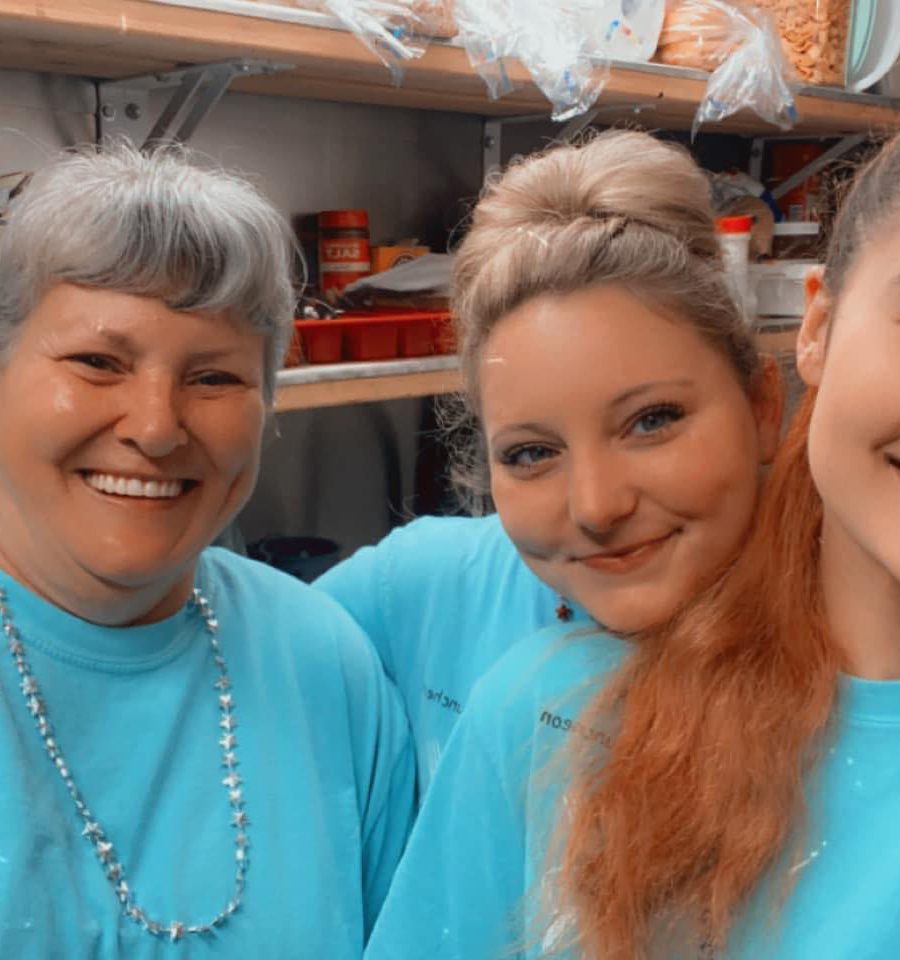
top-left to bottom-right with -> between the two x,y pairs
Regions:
0,0 -> 900,135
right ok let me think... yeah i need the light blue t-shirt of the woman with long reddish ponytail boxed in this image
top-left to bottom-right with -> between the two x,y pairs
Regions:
366,626 -> 900,960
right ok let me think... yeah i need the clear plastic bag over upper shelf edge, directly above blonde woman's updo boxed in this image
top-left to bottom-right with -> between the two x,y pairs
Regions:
454,0 -> 664,120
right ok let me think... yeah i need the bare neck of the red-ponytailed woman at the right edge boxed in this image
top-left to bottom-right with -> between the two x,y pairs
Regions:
820,511 -> 900,680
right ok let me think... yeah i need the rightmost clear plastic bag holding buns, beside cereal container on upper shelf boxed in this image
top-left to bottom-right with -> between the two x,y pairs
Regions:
656,0 -> 797,135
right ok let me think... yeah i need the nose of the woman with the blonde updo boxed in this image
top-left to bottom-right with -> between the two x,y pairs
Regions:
568,450 -> 639,536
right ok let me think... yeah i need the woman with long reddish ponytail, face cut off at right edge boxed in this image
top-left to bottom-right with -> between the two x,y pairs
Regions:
369,133 -> 900,960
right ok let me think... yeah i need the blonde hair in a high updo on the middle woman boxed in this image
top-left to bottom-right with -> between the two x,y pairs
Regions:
443,130 -> 761,507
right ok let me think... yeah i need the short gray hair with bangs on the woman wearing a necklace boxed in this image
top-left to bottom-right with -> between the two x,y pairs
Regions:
0,142 -> 295,403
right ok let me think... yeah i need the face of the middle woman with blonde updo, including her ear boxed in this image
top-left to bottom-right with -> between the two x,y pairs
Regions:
479,286 -> 779,633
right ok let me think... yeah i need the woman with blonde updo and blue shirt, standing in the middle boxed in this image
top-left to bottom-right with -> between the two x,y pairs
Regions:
316,132 -> 780,795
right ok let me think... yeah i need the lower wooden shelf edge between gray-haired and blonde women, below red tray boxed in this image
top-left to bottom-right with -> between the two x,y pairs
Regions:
275,357 -> 461,413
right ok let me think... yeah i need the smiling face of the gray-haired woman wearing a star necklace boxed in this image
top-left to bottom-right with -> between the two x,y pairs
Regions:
0,284 -> 265,622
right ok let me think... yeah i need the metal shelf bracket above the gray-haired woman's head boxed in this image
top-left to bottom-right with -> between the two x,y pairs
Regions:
97,57 -> 293,150
